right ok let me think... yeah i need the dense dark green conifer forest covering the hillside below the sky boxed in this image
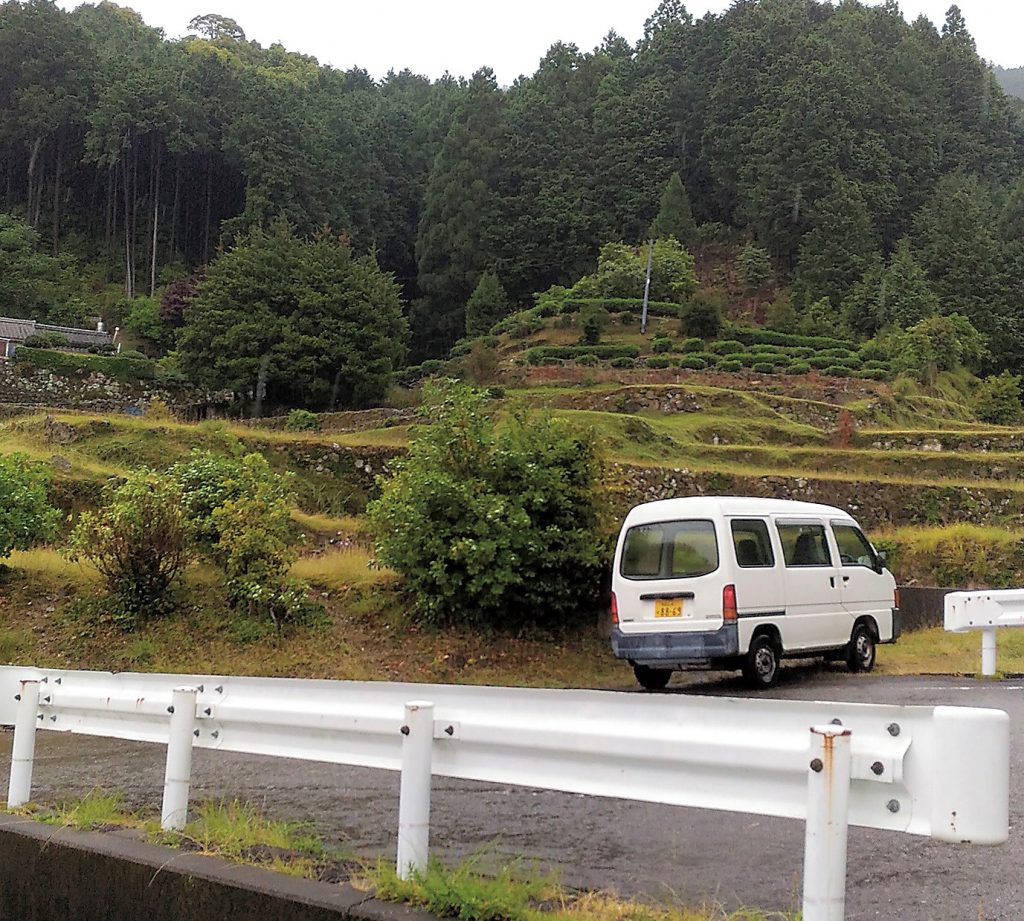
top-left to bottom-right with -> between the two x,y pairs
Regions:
0,0 -> 1024,379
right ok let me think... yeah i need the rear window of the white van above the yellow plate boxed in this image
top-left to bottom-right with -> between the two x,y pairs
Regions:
620,520 -> 718,579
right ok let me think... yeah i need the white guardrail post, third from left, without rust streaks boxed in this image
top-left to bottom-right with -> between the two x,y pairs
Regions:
396,701 -> 434,879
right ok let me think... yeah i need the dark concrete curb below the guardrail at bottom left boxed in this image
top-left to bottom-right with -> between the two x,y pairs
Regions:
0,813 -> 435,921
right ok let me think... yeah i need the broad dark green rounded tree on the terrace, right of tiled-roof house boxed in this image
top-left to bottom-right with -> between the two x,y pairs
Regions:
178,220 -> 407,415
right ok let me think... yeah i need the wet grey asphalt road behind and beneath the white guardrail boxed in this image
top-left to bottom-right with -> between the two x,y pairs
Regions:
0,666 -> 1024,921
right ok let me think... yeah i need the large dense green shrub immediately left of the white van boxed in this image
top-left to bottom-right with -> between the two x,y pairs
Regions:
368,381 -> 600,629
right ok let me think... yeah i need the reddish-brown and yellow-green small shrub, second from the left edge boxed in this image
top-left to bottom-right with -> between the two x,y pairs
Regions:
70,468 -> 193,625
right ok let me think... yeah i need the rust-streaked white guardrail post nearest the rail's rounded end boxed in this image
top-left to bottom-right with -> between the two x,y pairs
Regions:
803,725 -> 850,921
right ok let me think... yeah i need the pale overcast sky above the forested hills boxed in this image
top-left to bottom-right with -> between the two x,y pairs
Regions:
59,0 -> 1024,84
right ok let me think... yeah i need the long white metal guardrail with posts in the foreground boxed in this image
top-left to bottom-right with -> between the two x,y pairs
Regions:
0,667 -> 1010,921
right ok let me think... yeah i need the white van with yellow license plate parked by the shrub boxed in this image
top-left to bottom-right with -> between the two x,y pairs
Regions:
611,496 -> 900,689
